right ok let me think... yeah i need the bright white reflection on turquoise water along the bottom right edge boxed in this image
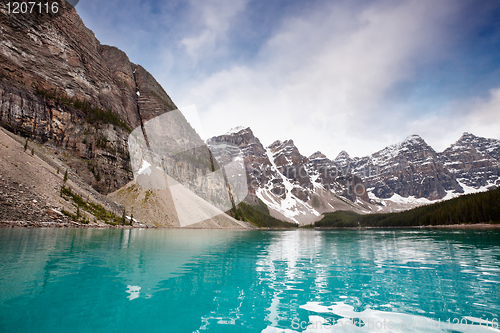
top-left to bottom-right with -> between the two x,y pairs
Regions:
262,302 -> 500,333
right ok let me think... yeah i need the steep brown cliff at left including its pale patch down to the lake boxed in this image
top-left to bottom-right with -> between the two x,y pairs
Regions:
0,1 -> 250,227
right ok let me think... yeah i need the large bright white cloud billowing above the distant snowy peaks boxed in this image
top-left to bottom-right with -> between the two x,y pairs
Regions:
179,1 -> 462,158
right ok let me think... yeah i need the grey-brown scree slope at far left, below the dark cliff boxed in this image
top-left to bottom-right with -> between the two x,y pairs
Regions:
0,128 -> 123,225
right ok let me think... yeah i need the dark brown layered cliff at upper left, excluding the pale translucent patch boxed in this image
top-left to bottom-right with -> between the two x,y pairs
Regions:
0,1 -> 176,193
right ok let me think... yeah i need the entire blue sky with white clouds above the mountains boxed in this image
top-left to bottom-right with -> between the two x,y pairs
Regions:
76,0 -> 500,158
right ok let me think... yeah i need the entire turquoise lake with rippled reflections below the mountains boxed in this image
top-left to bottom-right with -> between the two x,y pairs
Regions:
0,229 -> 500,333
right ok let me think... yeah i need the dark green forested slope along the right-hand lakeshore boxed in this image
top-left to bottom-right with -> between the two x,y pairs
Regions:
314,188 -> 500,228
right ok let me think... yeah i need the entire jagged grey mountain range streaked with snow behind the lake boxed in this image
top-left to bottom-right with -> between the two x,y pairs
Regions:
209,127 -> 500,224
